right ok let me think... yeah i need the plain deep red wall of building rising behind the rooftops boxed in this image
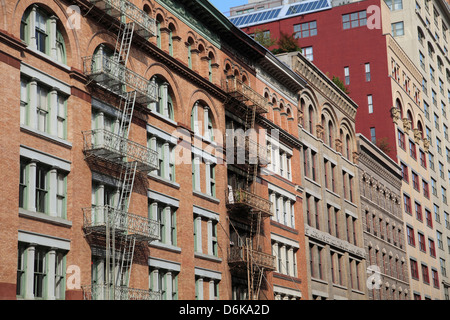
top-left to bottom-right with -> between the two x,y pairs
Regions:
242,0 -> 396,159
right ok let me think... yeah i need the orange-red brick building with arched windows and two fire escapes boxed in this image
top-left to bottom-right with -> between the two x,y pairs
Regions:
0,0 -> 308,299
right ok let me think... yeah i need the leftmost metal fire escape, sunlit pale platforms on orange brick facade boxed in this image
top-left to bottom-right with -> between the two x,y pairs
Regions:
83,0 -> 160,300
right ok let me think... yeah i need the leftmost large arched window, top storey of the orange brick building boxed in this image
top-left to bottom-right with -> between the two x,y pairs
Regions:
20,5 -> 67,63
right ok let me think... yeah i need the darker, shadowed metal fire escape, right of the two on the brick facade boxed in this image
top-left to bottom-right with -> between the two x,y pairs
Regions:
222,77 -> 275,300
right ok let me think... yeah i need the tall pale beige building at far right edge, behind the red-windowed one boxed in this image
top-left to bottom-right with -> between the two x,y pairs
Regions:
386,0 -> 450,299
